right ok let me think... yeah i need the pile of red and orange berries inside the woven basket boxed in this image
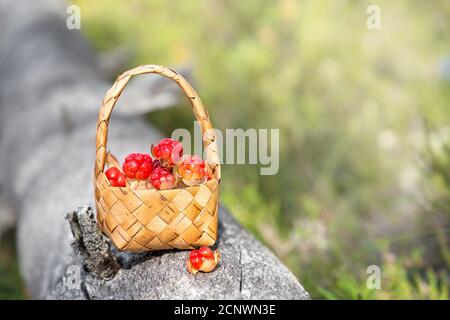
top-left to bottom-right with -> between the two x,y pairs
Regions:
105,138 -> 210,190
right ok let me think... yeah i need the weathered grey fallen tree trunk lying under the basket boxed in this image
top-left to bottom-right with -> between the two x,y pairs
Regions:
0,0 -> 308,299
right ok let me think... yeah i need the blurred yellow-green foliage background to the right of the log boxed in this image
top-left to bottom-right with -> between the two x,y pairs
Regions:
70,0 -> 450,299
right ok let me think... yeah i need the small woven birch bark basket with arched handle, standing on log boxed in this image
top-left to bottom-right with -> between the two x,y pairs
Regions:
94,65 -> 220,252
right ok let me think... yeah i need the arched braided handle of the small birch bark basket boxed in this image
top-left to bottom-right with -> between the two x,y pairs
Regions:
94,65 -> 220,181
